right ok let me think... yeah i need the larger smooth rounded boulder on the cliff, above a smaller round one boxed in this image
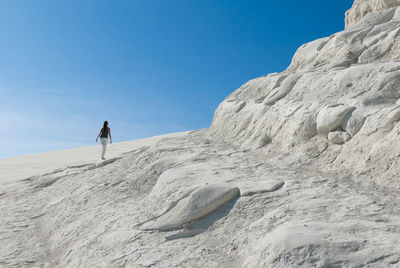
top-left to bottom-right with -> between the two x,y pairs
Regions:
317,104 -> 356,137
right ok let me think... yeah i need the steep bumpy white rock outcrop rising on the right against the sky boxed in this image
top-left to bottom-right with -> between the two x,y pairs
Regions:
210,0 -> 400,184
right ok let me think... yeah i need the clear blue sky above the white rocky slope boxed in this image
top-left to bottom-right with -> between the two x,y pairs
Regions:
0,0 -> 352,158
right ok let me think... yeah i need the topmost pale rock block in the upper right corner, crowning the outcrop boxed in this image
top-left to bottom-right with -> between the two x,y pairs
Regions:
346,0 -> 400,28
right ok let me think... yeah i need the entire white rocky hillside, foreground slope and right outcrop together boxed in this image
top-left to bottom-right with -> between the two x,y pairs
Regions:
0,0 -> 400,267
